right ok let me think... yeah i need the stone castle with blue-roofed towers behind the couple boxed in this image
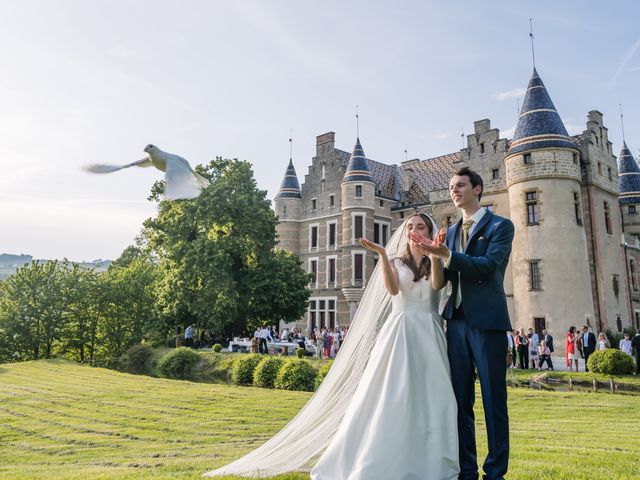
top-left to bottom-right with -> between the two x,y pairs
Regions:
274,69 -> 640,351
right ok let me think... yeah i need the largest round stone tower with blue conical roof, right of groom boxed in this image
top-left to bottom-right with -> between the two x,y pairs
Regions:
504,69 -> 594,344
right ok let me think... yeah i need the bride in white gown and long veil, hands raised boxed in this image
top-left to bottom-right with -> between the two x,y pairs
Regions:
206,213 -> 460,480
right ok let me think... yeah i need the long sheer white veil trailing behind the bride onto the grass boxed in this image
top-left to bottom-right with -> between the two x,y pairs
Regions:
205,217 -> 437,478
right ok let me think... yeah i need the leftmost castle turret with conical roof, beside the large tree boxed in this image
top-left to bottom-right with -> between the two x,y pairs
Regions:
274,159 -> 302,252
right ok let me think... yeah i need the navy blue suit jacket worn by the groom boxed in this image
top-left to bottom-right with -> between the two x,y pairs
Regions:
442,211 -> 514,330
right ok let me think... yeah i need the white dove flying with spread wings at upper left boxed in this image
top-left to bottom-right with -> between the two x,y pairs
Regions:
84,144 -> 209,200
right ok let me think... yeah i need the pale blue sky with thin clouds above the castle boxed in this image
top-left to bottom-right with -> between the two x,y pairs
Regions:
0,0 -> 640,260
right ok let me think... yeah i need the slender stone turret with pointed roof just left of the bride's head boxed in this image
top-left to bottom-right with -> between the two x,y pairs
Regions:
340,138 -> 375,320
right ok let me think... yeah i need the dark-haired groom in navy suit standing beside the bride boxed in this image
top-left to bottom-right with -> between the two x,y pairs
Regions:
412,167 -> 514,480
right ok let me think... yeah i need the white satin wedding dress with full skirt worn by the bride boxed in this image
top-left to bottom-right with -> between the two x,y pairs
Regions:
311,260 -> 460,480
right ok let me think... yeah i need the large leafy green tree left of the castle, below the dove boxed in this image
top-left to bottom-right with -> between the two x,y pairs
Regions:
144,158 -> 309,337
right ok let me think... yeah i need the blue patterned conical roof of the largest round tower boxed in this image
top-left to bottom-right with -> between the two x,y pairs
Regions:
507,68 -> 578,155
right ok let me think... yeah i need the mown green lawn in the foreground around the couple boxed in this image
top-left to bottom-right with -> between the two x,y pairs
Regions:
0,360 -> 640,480
